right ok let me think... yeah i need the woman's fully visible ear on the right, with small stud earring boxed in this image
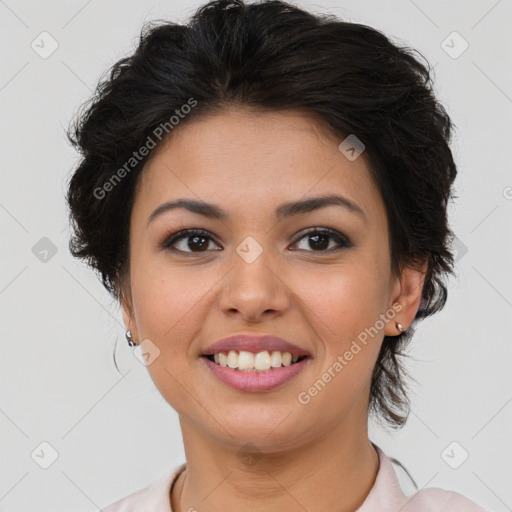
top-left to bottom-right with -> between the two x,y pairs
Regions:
384,260 -> 428,336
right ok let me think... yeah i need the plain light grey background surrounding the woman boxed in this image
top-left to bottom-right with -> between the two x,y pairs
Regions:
0,0 -> 512,512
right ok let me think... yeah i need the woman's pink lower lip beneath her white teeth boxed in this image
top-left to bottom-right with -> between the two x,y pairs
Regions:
201,356 -> 310,392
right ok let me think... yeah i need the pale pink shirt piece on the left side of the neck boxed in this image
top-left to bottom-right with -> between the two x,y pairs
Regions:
101,464 -> 185,512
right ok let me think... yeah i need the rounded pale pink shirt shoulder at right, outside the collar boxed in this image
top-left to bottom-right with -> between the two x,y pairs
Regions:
403,487 -> 486,512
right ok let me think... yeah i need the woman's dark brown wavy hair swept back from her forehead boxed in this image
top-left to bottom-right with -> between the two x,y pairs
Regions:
67,0 -> 457,428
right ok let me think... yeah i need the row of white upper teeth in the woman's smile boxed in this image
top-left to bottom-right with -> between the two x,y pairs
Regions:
209,350 -> 299,372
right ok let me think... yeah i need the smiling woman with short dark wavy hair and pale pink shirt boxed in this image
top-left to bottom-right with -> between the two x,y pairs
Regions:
68,0 -> 483,512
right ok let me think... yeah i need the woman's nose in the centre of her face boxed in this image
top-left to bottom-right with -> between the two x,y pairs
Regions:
219,242 -> 290,323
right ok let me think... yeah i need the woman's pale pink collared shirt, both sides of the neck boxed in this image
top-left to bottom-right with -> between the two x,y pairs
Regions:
103,444 -> 486,512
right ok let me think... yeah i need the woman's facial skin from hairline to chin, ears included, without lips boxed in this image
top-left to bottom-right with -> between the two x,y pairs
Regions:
123,108 -> 423,452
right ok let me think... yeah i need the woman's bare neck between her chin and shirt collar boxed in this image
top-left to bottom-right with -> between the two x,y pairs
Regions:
171,418 -> 379,512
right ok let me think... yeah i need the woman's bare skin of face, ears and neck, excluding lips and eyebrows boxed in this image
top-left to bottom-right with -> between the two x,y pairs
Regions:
122,107 -> 426,512
